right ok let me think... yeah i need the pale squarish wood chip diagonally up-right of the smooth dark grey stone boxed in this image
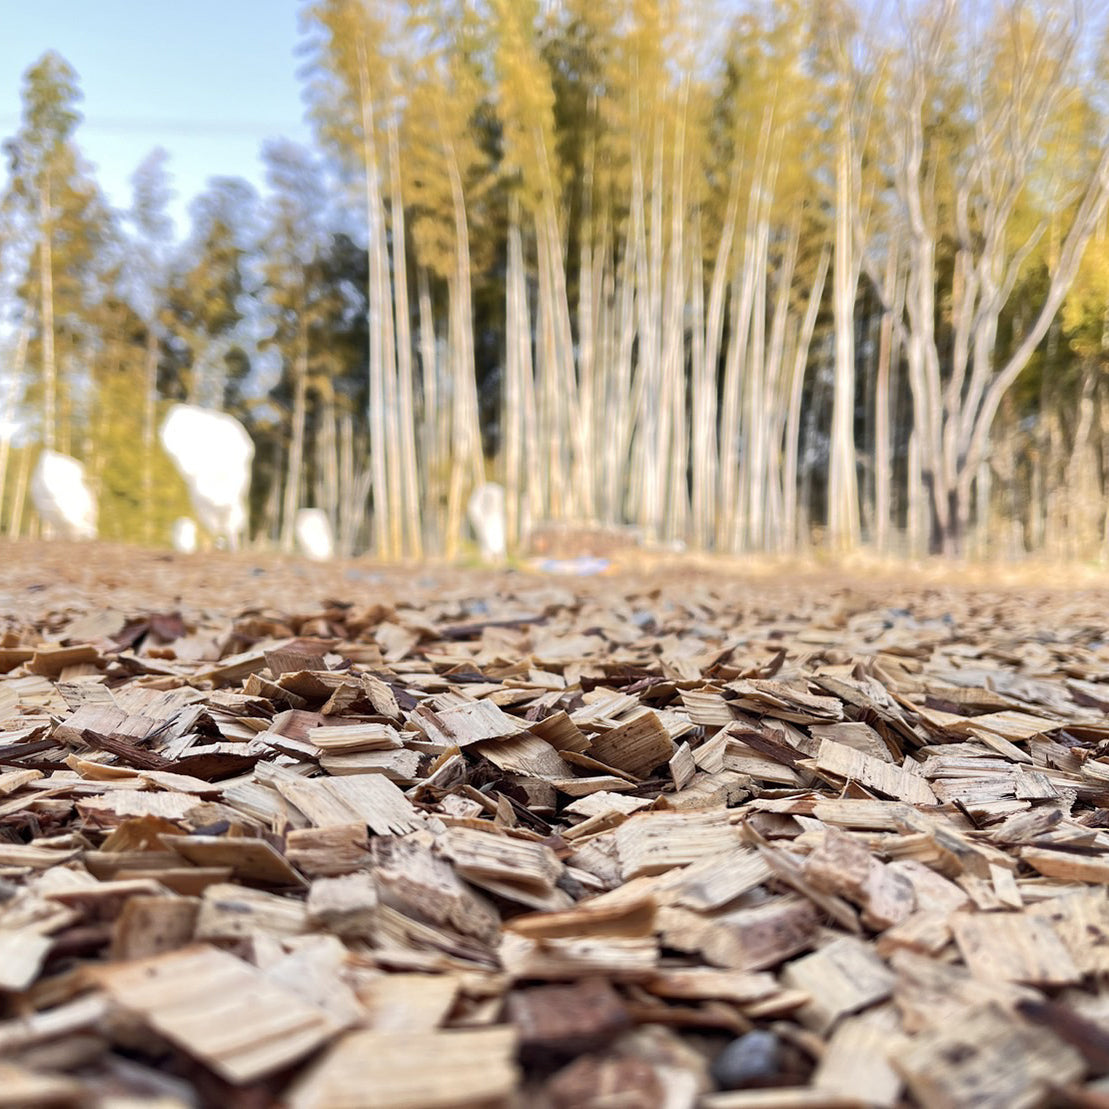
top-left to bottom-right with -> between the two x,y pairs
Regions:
782,936 -> 896,1034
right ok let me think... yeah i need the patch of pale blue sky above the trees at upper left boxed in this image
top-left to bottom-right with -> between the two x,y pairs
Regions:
0,0 -> 311,236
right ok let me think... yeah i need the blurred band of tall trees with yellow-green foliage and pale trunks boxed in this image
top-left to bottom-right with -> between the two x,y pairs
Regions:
0,0 -> 1109,559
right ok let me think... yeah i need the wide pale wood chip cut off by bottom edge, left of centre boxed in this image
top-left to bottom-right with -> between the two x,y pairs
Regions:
284,1027 -> 518,1109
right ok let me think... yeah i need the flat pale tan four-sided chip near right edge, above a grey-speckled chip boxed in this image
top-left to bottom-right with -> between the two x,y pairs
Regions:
950,913 -> 1082,986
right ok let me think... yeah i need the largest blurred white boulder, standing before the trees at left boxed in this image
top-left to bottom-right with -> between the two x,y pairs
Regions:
161,405 -> 254,550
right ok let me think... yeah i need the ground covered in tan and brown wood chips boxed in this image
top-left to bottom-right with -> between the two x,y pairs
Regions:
0,546 -> 1109,1109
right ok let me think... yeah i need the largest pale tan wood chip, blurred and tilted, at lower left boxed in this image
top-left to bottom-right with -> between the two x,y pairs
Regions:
98,946 -> 339,1083
